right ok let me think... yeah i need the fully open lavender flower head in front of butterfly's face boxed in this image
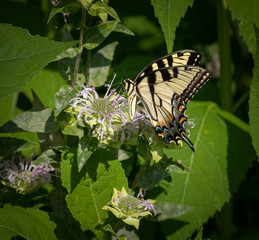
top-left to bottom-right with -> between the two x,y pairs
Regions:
70,77 -> 127,141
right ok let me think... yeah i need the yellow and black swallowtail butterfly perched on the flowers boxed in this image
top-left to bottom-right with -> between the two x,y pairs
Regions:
124,50 -> 210,151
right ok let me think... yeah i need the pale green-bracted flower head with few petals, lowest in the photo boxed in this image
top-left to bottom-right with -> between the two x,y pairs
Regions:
103,187 -> 155,229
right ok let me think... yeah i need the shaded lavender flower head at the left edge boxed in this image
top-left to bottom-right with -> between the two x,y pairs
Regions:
0,157 -> 55,194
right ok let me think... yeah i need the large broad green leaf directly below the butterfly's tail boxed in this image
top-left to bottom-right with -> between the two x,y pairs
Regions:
159,102 -> 255,239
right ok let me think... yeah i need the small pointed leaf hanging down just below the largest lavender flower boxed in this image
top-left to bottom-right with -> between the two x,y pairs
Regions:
77,136 -> 99,172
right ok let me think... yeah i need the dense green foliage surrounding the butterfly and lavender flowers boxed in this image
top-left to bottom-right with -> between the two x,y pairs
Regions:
0,0 -> 259,240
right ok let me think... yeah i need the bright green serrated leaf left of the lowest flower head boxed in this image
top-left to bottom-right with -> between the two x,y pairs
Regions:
61,149 -> 128,231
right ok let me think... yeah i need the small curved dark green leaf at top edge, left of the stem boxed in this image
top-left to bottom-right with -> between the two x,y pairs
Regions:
48,0 -> 81,23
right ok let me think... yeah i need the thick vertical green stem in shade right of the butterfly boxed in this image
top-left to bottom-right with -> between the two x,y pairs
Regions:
217,0 -> 233,111
